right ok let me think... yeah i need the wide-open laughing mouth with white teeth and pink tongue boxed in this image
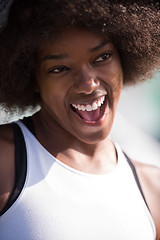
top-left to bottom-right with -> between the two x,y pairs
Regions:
71,96 -> 107,122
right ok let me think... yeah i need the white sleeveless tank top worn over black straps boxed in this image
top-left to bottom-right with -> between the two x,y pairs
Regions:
0,122 -> 156,240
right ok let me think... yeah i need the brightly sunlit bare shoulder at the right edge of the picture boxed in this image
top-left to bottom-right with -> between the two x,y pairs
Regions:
133,161 -> 160,240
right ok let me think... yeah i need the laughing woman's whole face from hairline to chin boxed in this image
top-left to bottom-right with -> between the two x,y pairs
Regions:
36,28 -> 123,143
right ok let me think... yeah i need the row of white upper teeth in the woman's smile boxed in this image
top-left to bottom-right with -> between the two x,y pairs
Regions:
72,96 -> 105,112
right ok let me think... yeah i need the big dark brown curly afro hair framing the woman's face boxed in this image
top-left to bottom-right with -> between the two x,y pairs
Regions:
0,0 -> 160,109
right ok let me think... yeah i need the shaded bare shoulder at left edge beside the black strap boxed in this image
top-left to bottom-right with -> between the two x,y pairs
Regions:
0,124 -> 15,213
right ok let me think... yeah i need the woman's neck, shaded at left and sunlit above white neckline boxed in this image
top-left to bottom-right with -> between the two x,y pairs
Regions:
33,110 -> 117,174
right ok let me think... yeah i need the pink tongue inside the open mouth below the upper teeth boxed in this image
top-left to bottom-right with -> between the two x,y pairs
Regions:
76,107 -> 100,122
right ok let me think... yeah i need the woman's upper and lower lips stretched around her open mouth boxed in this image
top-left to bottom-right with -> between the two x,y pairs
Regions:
70,95 -> 109,126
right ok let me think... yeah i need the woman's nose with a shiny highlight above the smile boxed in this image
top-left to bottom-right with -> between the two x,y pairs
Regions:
75,67 -> 100,94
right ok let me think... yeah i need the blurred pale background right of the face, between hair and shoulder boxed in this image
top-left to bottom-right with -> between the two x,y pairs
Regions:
111,73 -> 160,166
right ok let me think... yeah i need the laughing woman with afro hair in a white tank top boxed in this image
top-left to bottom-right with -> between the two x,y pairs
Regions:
0,0 -> 160,240
